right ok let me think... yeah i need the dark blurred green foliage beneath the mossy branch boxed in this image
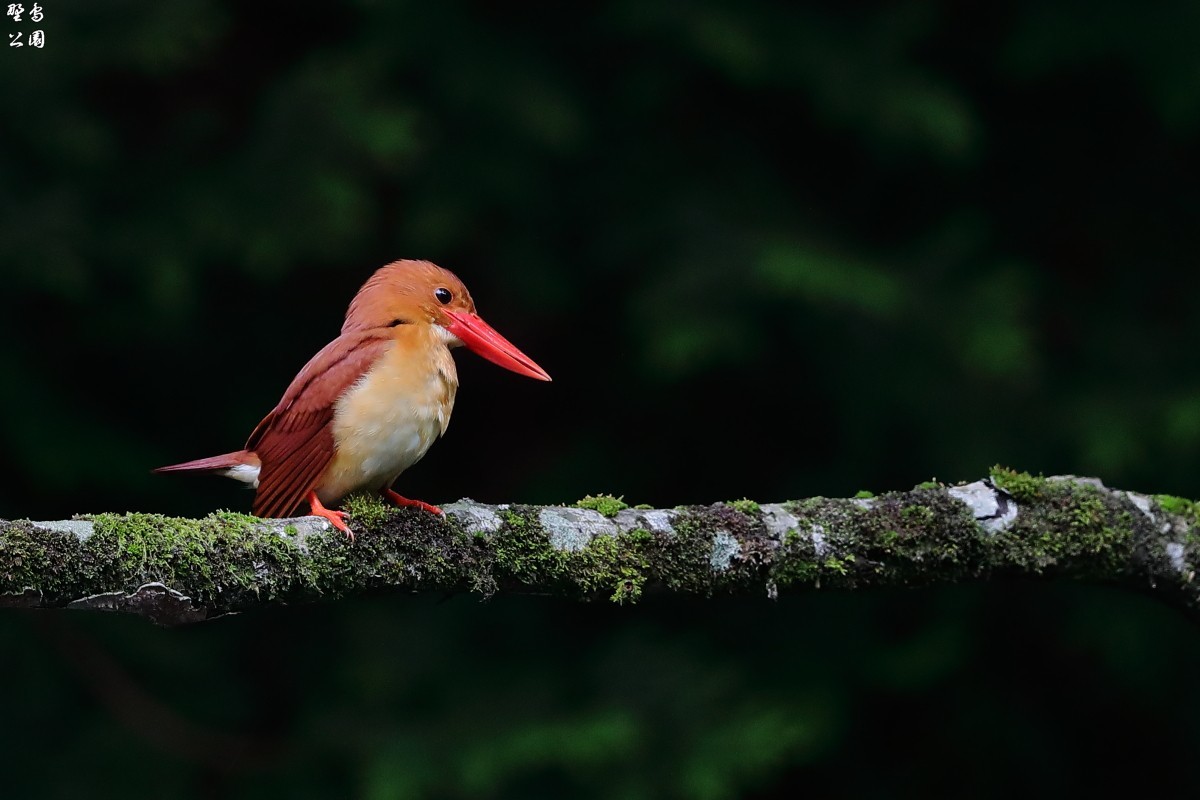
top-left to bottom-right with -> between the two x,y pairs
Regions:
7,585 -> 1200,800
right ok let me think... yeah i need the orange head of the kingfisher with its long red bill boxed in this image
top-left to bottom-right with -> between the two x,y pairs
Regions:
342,260 -> 550,380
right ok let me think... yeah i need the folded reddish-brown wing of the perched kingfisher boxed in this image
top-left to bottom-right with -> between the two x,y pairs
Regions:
246,331 -> 392,517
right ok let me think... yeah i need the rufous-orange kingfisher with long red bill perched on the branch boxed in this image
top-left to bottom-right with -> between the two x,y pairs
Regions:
155,260 -> 550,539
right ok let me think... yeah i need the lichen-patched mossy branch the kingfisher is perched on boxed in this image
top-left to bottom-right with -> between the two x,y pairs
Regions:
0,468 -> 1200,625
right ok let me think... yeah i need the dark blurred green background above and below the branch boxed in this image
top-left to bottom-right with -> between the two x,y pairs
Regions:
0,0 -> 1200,800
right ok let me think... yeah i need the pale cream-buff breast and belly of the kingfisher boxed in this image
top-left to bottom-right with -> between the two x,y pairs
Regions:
317,342 -> 458,503
